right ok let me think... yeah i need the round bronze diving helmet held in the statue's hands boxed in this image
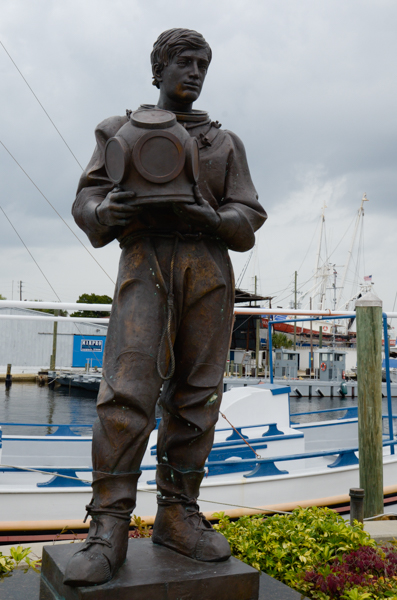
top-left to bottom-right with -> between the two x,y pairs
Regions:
105,108 -> 199,205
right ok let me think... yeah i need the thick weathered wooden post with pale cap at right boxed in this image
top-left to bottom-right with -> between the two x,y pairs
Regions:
356,292 -> 383,518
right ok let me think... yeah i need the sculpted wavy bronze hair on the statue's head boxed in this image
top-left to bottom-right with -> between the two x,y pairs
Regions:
150,29 -> 212,88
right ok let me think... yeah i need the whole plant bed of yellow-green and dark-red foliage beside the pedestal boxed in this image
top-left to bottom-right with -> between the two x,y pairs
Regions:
214,507 -> 397,600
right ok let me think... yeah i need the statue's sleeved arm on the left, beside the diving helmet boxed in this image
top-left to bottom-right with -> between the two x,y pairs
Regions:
72,117 -> 127,248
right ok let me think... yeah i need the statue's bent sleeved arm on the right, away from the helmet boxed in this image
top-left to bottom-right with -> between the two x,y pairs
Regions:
216,132 -> 267,252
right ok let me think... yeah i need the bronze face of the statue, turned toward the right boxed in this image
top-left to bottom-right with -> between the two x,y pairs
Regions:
160,50 -> 209,104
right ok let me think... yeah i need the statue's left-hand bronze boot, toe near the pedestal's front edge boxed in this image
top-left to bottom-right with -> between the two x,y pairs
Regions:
63,472 -> 140,587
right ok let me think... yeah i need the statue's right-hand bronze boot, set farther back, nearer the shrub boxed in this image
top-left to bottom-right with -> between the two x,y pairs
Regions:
152,464 -> 231,562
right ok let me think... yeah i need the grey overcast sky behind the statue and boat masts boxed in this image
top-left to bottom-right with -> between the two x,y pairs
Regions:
0,0 -> 397,310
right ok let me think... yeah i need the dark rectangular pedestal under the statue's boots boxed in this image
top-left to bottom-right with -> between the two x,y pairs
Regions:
40,539 -> 260,600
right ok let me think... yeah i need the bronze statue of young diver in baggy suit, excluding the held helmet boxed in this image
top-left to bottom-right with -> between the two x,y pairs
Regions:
65,29 -> 266,586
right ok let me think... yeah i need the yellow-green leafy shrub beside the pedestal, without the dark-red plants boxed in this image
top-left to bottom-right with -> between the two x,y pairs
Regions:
215,507 -> 376,597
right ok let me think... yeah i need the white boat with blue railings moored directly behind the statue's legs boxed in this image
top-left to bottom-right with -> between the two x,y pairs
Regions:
0,384 -> 397,530
